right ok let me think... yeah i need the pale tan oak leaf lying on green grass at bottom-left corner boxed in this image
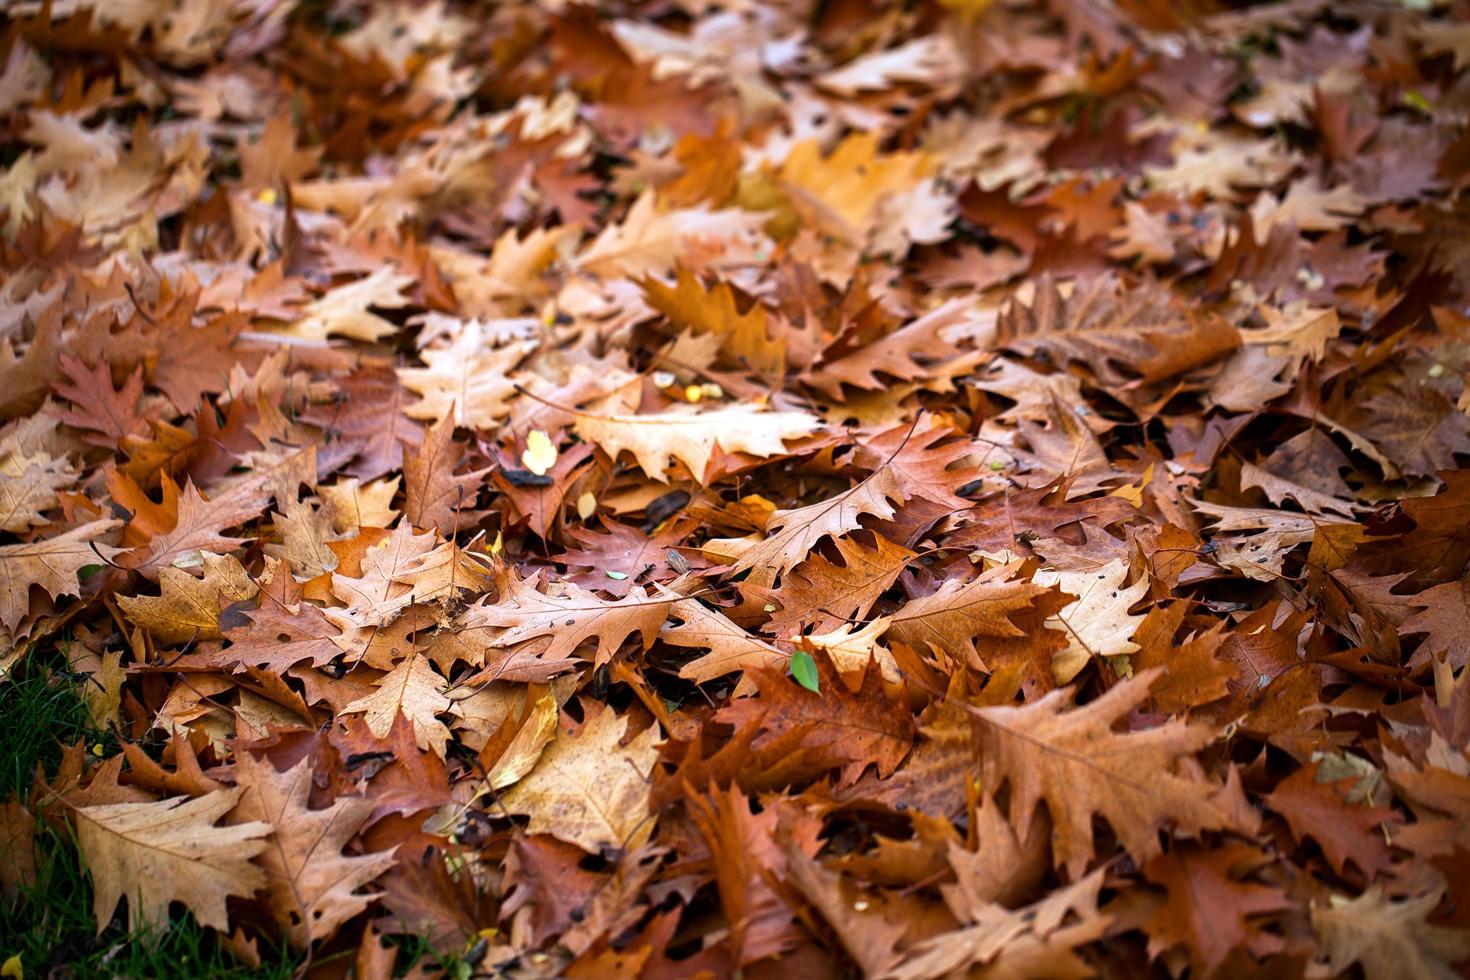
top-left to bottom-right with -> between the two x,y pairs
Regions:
72,789 -> 272,933
